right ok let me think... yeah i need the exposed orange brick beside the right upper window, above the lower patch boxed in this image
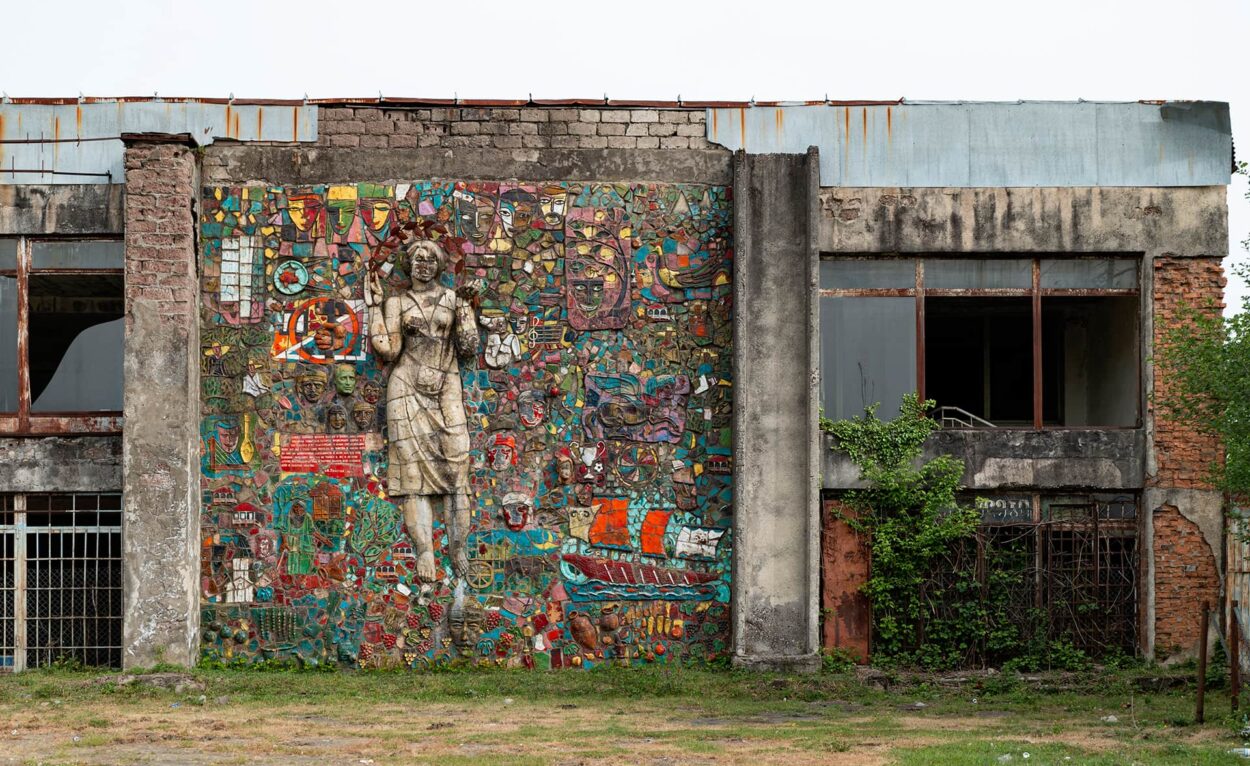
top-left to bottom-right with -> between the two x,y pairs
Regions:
1148,256 -> 1225,490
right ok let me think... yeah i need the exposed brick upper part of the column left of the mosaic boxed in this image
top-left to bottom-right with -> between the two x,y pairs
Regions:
125,142 -> 196,334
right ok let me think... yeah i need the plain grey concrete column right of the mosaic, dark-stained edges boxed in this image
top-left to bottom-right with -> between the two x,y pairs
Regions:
734,149 -> 820,670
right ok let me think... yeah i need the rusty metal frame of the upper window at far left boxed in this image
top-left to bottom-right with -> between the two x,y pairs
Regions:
0,236 -> 125,436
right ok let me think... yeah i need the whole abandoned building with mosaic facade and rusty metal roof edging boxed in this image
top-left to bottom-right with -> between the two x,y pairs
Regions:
0,99 -> 1233,671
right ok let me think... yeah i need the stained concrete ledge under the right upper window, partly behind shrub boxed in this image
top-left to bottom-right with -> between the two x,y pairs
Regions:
821,429 -> 1146,490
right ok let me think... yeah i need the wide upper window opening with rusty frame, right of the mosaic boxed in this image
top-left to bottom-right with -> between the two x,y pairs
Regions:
820,256 -> 1141,427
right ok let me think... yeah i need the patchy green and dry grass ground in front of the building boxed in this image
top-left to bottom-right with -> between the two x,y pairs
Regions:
0,667 -> 1250,766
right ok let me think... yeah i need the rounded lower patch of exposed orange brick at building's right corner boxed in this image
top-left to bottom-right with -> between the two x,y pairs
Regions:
1154,505 -> 1220,656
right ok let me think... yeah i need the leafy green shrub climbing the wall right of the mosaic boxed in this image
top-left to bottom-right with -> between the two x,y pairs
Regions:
820,394 -> 1110,672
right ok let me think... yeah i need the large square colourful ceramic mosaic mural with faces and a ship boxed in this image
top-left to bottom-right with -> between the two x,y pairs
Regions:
200,181 -> 733,667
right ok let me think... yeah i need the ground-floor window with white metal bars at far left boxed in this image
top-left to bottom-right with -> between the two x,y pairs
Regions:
0,494 -> 123,672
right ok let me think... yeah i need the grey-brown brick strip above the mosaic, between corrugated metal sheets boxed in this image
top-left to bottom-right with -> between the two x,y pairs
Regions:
318,106 -> 719,149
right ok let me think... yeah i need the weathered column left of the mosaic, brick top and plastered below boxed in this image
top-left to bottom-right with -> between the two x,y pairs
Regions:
123,135 -> 200,667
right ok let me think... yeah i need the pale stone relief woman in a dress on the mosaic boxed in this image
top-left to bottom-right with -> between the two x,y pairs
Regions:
365,240 -> 478,582
